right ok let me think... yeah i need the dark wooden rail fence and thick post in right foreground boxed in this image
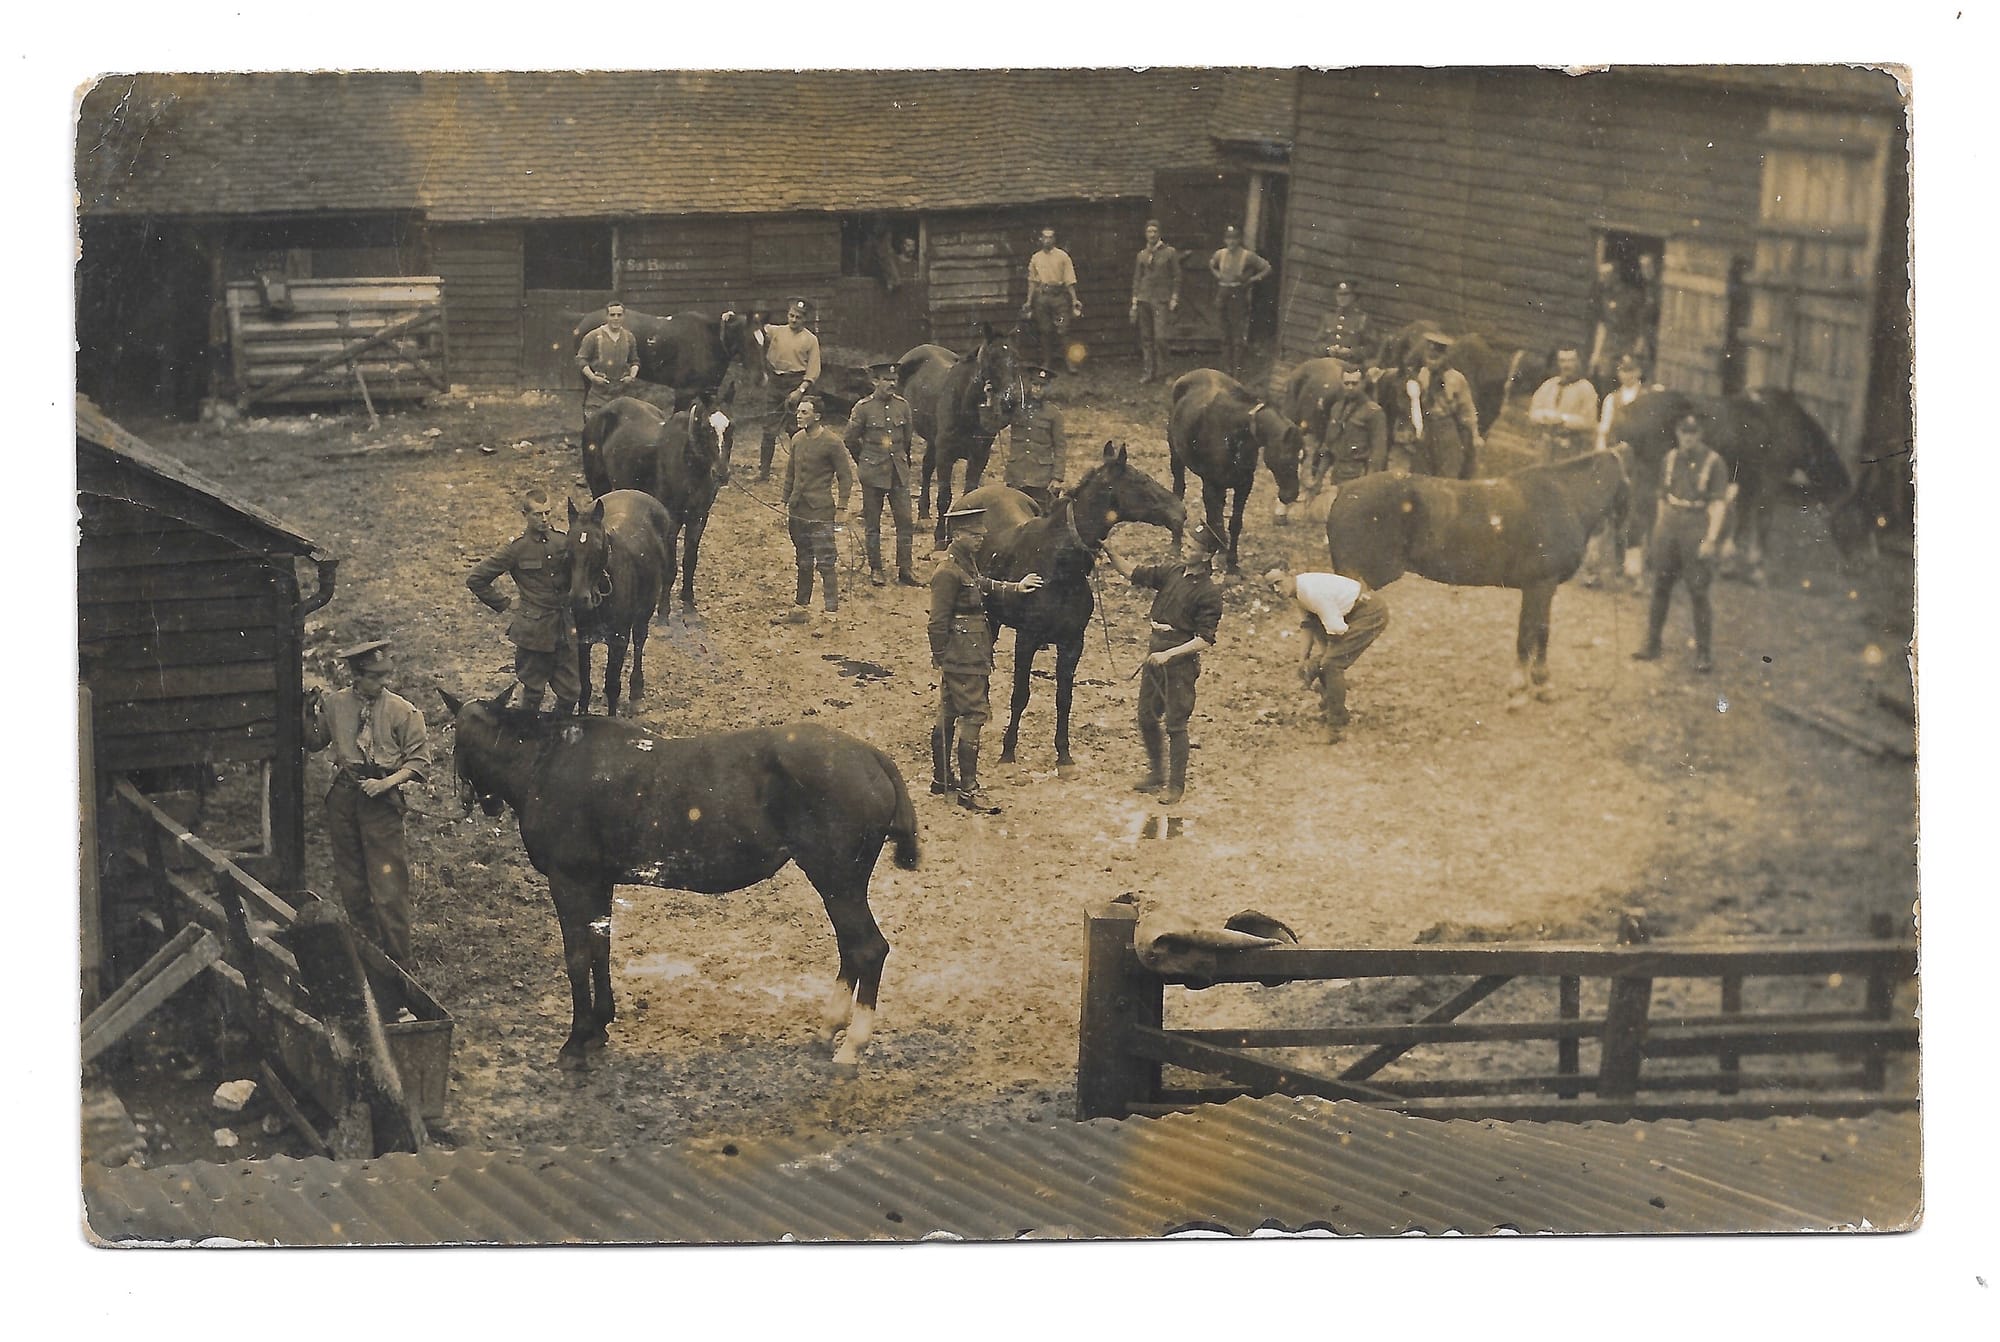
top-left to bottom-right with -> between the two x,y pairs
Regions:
1076,904 -> 1918,1122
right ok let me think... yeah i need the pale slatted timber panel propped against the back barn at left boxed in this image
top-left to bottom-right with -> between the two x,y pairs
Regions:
228,276 -> 446,408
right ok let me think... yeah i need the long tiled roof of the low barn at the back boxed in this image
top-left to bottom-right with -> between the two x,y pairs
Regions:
76,70 -> 1224,220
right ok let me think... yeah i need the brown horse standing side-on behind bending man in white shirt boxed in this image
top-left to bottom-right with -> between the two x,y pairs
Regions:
1326,450 -> 1632,708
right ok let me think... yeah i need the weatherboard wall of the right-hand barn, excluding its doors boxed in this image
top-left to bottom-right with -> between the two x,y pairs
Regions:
1280,70 -> 1764,368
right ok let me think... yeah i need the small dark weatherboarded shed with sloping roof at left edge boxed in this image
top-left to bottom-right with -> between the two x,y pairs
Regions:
76,396 -> 338,908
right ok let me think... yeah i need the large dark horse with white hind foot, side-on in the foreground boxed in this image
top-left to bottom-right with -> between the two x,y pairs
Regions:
440,686 -> 918,1068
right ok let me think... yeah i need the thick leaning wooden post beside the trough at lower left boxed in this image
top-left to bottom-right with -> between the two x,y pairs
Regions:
288,900 -> 428,1156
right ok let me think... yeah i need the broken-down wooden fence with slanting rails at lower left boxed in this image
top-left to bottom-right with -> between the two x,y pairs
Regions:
82,778 -> 454,1158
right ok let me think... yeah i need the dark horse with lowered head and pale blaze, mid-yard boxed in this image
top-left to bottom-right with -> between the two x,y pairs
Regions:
1166,368 -> 1306,574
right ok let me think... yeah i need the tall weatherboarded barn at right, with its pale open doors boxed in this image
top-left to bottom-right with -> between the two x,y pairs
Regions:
1280,66 -> 1912,462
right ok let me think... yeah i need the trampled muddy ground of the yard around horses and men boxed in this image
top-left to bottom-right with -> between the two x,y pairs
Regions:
113,368 -> 1916,1158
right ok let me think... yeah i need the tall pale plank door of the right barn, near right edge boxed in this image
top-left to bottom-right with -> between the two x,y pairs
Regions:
1746,108 -> 1892,462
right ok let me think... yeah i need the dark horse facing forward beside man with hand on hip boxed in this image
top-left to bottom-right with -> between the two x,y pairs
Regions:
566,490 -> 674,716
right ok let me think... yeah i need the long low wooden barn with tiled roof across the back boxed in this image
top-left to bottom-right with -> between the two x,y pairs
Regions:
78,70 -> 1294,412
